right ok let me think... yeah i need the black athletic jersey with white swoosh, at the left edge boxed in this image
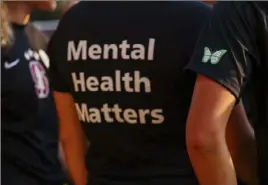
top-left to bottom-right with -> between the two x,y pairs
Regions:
1,24 -> 65,182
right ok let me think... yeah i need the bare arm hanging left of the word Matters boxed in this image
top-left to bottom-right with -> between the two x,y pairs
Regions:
54,92 -> 87,185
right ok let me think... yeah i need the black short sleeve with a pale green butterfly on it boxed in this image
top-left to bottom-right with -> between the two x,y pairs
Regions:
186,2 -> 257,99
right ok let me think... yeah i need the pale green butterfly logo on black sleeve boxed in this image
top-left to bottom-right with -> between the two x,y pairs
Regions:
202,47 -> 227,64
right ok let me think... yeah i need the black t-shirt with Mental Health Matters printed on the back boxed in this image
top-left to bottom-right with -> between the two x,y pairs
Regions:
48,2 -> 210,185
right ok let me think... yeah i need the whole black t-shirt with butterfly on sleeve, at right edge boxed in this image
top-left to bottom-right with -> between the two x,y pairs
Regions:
187,2 -> 268,185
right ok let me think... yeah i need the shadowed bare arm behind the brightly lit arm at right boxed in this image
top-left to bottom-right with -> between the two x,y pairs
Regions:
226,102 -> 258,185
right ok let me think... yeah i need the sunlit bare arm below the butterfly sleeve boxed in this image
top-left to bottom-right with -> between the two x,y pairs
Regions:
186,75 -> 237,185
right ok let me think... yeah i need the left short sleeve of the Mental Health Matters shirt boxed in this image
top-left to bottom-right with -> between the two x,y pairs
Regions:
47,20 -> 71,92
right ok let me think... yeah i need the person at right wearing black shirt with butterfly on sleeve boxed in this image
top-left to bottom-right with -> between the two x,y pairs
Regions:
186,1 -> 268,185
